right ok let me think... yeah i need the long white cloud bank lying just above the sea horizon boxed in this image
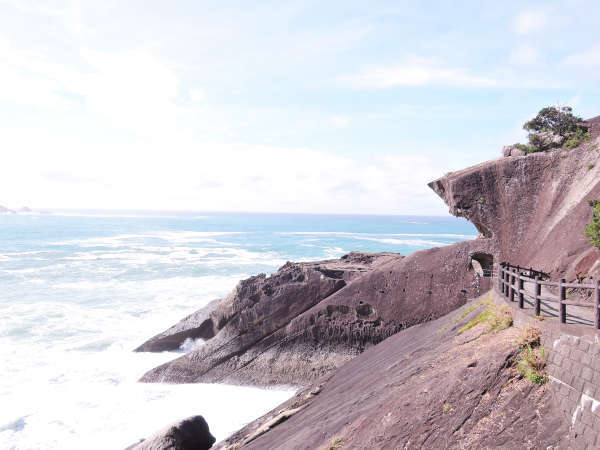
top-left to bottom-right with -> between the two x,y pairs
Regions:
0,120 -> 447,214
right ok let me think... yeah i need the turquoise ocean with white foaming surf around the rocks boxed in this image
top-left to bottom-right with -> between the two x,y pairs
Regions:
0,211 -> 477,449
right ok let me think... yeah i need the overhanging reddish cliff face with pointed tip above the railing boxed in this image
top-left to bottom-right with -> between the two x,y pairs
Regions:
429,139 -> 600,280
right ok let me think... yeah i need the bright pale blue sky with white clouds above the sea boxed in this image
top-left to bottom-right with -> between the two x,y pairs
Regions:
0,0 -> 600,215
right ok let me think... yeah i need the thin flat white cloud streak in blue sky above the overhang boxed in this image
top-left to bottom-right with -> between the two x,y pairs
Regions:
342,58 -> 499,89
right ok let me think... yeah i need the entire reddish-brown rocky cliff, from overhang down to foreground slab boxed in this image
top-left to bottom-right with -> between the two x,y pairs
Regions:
139,118 -> 600,448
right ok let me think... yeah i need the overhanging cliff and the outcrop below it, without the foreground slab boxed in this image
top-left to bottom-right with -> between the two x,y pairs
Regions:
138,119 -> 600,385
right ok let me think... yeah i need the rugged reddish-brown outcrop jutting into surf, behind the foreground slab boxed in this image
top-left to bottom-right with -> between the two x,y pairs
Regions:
140,246 -> 489,385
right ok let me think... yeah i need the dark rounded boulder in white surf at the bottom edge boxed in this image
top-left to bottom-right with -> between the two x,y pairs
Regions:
125,416 -> 215,450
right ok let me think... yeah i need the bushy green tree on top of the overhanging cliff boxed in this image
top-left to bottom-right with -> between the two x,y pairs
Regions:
519,106 -> 589,152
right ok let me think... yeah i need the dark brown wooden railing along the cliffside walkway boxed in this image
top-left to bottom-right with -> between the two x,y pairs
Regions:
498,262 -> 600,329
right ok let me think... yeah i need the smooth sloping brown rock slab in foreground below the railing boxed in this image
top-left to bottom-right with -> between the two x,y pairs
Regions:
218,303 -> 568,450
